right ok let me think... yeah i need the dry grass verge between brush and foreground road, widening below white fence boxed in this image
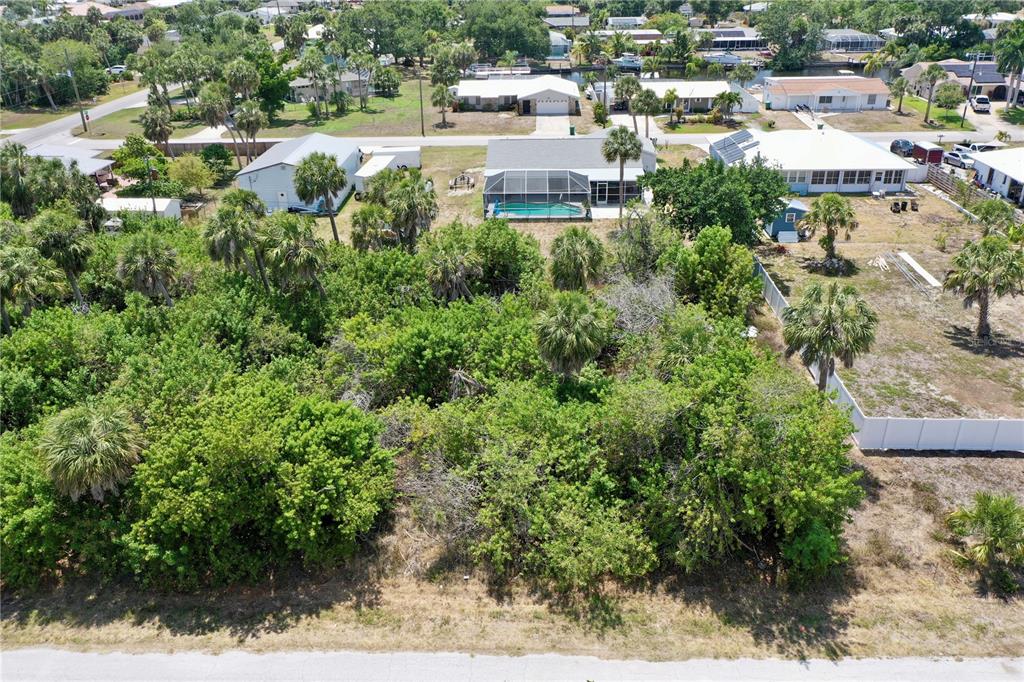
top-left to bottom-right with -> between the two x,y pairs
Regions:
2,446 -> 1024,659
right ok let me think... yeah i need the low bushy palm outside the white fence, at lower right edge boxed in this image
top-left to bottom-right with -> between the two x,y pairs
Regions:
947,493 -> 1024,581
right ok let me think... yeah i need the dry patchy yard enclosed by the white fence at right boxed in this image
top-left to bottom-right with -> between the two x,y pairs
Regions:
760,190 -> 1024,417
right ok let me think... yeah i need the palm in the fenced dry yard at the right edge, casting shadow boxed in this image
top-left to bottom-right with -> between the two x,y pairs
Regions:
942,235 -> 1024,341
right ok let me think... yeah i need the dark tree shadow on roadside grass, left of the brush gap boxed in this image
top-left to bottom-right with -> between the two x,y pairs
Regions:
2,536 -> 381,644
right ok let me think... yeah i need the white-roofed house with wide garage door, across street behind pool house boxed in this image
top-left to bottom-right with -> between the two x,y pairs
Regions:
452,76 -> 580,116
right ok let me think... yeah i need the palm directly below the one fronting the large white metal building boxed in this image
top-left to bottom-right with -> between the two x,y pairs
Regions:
267,212 -> 327,298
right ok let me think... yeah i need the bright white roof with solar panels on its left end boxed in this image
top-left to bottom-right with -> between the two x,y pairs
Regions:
716,128 -> 915,171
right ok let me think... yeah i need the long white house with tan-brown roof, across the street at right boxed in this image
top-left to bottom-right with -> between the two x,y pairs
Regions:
764,76 -> 889,112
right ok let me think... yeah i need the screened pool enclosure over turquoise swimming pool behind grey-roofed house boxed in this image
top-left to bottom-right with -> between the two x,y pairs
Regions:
483,170 -> 590,220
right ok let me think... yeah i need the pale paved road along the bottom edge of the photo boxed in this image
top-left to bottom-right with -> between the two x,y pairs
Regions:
0,649 -> 1024,682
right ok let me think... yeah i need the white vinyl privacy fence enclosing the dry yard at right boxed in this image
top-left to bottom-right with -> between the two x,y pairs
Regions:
754,258 -> 1024,452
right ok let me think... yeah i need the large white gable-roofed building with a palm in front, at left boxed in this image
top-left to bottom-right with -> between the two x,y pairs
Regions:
236,133 -> 359,211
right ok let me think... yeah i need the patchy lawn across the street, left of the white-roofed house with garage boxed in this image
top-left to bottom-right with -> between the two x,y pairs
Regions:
244,80 -> 540,137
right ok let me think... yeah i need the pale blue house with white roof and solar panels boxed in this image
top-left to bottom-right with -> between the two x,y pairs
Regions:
711,128 -> 925,195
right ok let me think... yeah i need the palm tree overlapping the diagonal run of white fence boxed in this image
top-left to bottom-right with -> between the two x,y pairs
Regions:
782,282 -> 879,391
